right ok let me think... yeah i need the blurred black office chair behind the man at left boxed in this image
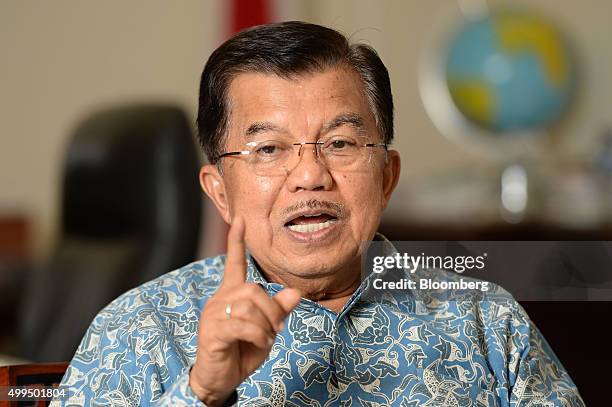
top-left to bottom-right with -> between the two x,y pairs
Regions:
20,105 -> 202,362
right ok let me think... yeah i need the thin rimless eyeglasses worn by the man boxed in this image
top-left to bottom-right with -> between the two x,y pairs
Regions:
219,136 -> 387,176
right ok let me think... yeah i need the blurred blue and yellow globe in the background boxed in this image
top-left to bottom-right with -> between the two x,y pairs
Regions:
445,11 -> 576,135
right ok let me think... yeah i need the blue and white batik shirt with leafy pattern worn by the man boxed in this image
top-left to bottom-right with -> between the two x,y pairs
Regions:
52,237 -> 584,407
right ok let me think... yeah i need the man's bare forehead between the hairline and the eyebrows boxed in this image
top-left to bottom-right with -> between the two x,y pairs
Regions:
228,68 -> 374,138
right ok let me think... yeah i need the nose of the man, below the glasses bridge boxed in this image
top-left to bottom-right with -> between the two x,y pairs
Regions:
287,144 -> 333,192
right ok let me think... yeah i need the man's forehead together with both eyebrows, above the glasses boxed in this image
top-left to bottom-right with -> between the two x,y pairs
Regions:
224,69 -> 378,151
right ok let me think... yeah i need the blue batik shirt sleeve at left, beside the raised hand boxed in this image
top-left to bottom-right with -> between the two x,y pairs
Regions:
51,297 -> 204,407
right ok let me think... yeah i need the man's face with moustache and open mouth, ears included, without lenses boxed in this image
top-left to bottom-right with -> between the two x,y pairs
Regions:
202,68 -> 399,284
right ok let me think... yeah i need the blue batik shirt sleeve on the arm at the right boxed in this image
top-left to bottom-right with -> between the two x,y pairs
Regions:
510,304 -> 585,407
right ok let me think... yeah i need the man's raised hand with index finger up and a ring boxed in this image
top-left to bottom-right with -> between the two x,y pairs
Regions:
189,217 -> 300,407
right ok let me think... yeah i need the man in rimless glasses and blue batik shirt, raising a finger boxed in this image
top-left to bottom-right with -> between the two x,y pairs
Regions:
54,22 -> 583,406
